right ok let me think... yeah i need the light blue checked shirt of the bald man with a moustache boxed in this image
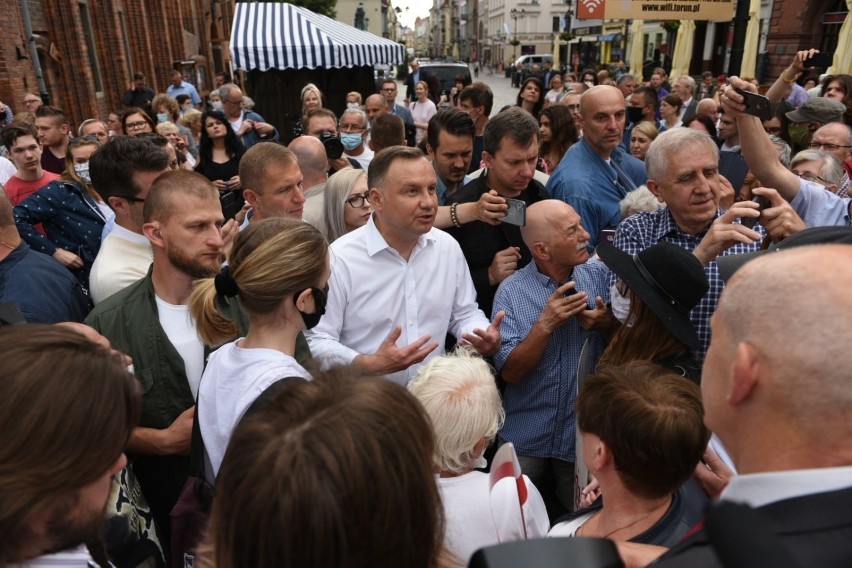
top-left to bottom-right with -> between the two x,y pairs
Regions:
494,260 -> 609,462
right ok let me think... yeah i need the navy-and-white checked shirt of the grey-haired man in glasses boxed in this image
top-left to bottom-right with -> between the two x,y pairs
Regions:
611,207 -> 766,363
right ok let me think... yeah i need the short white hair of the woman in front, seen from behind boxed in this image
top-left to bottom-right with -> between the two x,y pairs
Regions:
408,348 -> 506,473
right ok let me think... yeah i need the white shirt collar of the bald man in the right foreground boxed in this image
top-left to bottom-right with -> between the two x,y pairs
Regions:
719,466 -> 852,507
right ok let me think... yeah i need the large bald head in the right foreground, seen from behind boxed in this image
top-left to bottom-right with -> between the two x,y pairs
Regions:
702,245 -> 852,448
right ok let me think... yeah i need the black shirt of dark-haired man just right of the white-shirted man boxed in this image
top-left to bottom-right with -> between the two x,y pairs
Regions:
446,172 -> 550,316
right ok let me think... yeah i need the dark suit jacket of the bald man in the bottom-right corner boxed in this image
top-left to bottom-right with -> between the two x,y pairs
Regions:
654,487 -> 852,568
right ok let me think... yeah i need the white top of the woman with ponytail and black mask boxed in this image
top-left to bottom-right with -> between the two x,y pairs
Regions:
196,339 -> 311,481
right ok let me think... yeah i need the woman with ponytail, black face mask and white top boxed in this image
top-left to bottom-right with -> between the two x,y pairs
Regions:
190,218 -> 330,482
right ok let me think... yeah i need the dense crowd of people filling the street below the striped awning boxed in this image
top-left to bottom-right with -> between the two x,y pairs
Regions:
0,50 -> 852,568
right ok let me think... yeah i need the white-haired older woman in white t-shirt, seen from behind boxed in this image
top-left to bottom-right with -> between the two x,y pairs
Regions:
408,348 -> 549,566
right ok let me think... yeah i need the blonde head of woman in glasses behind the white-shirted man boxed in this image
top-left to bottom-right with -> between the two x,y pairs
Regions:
321,168 -> 373,243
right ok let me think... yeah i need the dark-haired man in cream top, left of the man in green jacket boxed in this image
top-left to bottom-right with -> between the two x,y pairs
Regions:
89,136 -> 169,304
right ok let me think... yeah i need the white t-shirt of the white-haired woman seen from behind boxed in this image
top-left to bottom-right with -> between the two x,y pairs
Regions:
437,471 -> 550,565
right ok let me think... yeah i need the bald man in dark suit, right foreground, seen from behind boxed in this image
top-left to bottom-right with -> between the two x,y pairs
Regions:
644,245 -> 852,568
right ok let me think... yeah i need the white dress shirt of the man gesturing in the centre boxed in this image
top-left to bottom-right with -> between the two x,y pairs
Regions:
305,217 -> 489,385
